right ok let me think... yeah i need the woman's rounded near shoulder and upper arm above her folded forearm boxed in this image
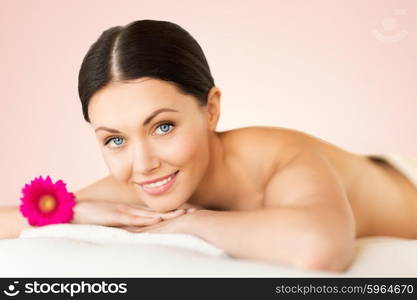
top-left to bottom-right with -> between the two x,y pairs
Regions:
262,149 -> 359,237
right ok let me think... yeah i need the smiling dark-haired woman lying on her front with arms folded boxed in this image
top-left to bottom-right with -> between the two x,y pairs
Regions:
1,20 -> 417,271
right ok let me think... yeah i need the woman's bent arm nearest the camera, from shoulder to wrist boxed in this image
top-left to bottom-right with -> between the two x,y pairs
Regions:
185,151 -> 356,271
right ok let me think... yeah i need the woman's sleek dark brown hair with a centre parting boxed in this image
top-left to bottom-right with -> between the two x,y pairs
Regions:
78,20 -> 215,122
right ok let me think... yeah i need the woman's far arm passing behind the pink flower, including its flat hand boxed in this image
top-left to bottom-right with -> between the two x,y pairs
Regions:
0,176 -> 185,239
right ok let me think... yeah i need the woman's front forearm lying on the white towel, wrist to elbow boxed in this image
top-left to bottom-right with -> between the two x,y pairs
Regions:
188,208 -> 353,271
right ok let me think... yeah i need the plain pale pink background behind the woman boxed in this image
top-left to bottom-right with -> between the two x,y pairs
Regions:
0,0 -> 417,204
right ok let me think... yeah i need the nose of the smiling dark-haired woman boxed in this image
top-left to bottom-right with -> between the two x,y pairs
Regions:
132,141 -> 159,174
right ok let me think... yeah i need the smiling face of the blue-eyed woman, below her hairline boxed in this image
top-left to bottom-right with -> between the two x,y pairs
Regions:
89,78 -> 215,212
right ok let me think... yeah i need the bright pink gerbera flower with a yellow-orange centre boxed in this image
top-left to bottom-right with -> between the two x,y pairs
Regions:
20,176 -> 76,226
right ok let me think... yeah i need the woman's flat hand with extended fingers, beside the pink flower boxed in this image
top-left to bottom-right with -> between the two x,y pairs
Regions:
71,199 -> 186,227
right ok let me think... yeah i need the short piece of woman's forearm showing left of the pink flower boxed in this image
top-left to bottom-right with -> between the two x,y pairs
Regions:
0,206 -> 30,239
